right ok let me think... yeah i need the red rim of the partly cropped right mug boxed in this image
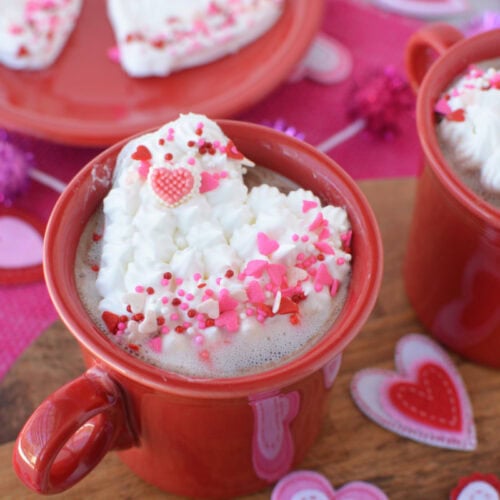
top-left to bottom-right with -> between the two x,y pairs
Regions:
417,29 -> 500,223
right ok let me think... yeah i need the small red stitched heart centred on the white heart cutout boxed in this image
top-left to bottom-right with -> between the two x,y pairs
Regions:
388,363 -> 462,431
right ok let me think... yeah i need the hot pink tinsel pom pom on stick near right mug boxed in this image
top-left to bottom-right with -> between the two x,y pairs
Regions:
348,67 -> 415,140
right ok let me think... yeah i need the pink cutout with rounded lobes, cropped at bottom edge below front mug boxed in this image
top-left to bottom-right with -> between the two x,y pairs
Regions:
271,471 -> 387,500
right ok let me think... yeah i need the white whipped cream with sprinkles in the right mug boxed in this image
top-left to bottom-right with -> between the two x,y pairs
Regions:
436,61 -> 500,194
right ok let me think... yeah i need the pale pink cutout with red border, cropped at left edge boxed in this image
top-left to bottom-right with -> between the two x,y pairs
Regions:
0,208 -> 45,285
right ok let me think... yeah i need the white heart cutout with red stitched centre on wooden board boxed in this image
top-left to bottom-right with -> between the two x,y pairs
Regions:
351,334 -> 476,450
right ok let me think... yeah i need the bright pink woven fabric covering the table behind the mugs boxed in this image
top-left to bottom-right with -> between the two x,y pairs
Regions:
0,0 -> 421,379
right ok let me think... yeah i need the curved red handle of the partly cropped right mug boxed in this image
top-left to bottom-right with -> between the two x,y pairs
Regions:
405,23 -> 464,93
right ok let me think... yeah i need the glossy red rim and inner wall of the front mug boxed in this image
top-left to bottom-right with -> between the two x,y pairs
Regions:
44,120 -> 382,397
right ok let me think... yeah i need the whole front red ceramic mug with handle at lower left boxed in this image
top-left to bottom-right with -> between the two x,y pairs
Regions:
13,120 -> 382,498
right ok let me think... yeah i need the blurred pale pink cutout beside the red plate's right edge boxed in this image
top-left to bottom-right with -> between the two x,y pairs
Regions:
289,33 -> 352,85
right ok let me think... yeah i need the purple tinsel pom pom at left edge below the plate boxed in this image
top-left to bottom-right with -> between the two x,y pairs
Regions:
0,131 -> 33,206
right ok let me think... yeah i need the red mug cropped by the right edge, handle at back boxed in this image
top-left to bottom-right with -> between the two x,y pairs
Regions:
404,24 -> 500,368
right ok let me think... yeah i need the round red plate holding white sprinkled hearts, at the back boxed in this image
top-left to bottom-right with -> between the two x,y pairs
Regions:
0,0 -> 324,146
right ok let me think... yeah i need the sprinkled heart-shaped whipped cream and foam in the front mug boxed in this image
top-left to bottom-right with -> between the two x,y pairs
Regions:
77,114 -> 351,376
